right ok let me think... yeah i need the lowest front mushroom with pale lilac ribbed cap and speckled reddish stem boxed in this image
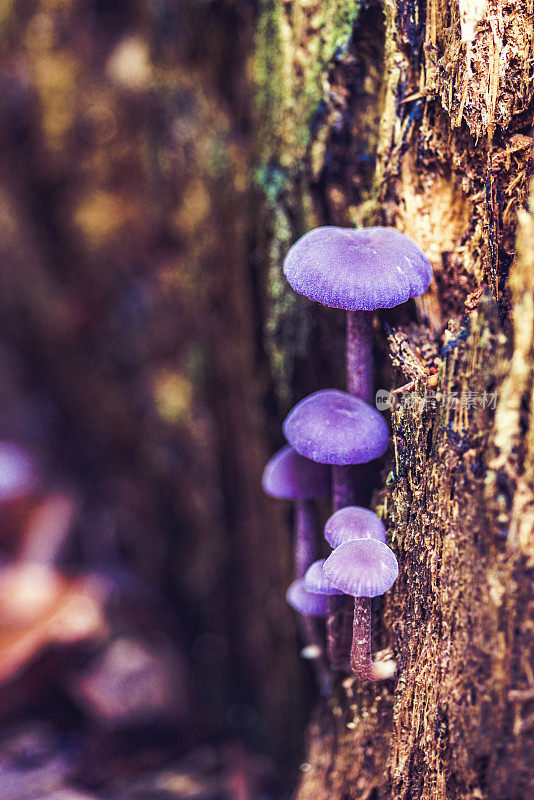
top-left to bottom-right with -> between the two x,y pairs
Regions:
323,539 -> 399,680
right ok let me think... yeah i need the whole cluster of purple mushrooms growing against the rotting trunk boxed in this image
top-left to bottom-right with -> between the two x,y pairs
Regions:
263,226 -> 432,693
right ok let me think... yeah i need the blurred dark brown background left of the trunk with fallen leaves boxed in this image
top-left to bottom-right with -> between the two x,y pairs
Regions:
0,0 -> 322,800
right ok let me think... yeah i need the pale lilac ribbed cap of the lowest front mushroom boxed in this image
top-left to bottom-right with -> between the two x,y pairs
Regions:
323,539 -> 399,597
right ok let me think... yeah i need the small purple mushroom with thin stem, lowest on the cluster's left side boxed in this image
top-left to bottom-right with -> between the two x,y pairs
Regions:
286,578 -> 332,697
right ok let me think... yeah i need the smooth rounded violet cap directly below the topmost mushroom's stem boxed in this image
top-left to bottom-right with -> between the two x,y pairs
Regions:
284,389 -> 389,465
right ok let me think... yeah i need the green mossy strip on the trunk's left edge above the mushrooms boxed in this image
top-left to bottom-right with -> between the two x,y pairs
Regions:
254,0 -> 360,402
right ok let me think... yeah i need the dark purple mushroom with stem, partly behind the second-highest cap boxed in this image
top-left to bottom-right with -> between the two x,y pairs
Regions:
262,445 -> 330,578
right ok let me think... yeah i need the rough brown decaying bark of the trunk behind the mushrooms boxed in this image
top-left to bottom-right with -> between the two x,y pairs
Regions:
256,0 -> 534,800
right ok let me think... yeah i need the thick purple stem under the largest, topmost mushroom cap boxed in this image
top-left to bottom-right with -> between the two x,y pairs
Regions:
347,311 -> 375,404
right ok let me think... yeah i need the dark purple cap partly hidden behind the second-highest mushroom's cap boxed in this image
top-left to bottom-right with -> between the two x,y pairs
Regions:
261,445 -> 330,500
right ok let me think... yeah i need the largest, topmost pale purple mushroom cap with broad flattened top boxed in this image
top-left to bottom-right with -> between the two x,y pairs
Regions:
284,226 -> 432,311
